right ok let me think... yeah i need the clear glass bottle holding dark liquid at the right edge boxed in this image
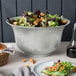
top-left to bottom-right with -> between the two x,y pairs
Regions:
67,23 -> 76,58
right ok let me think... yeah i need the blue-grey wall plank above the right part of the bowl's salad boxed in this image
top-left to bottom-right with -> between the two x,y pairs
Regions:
47,0 -> 62,15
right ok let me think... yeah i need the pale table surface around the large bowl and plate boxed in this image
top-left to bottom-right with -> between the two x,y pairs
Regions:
0,42 -> 76,75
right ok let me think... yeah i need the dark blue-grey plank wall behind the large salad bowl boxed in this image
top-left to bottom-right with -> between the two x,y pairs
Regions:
0,0 -> 76,42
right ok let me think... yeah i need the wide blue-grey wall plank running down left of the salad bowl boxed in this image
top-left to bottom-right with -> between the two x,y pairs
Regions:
1,0 -> 16,42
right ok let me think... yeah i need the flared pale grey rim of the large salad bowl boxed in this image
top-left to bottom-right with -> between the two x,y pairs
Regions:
6,16 -> 71,28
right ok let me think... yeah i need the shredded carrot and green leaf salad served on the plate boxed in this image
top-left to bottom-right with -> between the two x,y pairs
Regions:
41,60 -> 76,76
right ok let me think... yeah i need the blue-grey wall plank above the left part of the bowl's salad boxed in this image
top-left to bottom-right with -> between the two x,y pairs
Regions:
17,0 -> 31,16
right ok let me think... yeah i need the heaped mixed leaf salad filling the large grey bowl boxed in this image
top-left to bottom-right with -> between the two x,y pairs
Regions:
7,10 -> 67,27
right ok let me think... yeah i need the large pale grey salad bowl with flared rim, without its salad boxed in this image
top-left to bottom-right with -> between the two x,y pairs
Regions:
6,17 -> 70,57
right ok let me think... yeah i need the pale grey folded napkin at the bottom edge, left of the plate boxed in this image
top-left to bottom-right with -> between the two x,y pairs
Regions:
8,67 -> 35,76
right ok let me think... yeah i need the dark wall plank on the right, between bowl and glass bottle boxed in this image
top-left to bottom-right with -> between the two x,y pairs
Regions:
62,0 -> 76,41
